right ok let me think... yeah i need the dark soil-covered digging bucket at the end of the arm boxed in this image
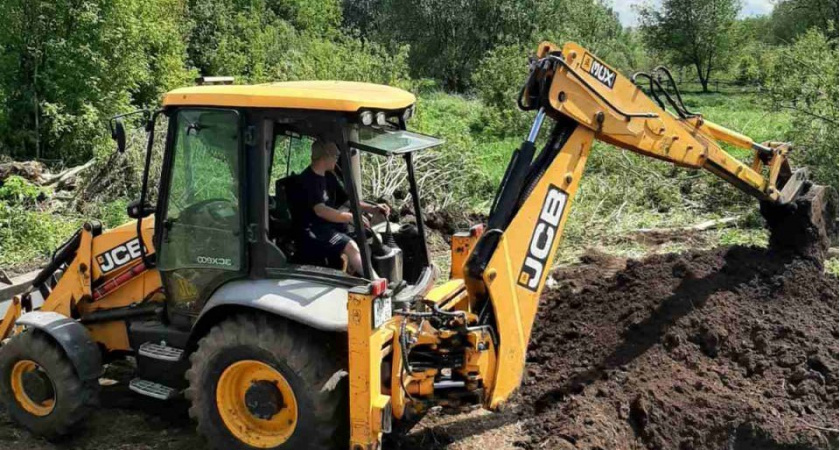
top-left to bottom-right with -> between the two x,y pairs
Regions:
761,182 -> 837,261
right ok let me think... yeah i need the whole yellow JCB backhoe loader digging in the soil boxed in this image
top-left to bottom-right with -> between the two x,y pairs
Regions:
0,43 -> 822,450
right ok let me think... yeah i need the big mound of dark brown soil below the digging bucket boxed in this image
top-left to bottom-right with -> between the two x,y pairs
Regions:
517,247 -> 838,450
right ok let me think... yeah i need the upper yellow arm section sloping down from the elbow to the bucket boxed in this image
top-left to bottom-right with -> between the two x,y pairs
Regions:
521,43 -> 804,203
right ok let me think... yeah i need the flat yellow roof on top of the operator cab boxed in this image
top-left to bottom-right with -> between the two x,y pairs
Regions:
163,81 -> 416,112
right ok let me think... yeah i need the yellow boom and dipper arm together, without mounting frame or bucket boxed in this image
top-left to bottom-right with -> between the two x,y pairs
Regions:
465,43 -> 807,408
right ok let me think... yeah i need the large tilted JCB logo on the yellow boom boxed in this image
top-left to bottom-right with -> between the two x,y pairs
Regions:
519,184 -> 568,292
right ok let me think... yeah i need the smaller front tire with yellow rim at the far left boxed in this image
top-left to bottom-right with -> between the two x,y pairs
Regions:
0,330 -> 99,439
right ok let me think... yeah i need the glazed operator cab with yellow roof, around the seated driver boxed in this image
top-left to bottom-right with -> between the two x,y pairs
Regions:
123,81 -> 442,327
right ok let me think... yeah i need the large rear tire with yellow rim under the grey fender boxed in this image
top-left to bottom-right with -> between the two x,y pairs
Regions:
186,314 -> 349,450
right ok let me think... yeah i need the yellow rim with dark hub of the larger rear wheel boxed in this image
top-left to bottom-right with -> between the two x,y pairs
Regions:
216,360 -> 298,448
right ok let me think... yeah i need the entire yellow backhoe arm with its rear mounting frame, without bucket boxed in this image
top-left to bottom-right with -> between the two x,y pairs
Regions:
348,43 -> 810,449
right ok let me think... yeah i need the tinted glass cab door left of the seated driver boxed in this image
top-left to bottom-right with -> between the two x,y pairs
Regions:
156,108 -> 247,320
